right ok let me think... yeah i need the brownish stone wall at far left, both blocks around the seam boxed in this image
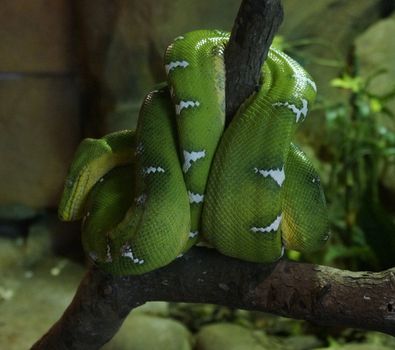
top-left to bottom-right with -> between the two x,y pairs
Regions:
0,0 -> 81,208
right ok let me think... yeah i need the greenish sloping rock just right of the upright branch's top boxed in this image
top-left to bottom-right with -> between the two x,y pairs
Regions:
280,0 -> 390,101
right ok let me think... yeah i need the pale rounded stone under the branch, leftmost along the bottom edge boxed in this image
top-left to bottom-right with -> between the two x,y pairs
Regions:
103,313 -> 192,350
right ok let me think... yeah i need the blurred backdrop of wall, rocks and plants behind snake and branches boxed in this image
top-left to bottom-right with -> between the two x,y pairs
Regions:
0,0 -> 395,350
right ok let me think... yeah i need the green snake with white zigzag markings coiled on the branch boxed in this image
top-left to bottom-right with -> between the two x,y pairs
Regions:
59,30 -> 329,275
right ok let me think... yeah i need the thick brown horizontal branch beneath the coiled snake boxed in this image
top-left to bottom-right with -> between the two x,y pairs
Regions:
33,247 -> 395,350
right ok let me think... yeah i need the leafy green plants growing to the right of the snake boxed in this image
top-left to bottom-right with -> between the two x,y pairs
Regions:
314,61 -> 395,269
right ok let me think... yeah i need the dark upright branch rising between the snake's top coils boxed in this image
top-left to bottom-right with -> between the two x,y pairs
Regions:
225,0 -> 283,124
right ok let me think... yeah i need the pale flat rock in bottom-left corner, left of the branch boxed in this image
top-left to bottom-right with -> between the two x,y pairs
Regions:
0,209 -> 86,350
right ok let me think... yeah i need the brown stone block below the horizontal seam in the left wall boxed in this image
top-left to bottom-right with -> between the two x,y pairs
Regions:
0,76 -> 80,210
